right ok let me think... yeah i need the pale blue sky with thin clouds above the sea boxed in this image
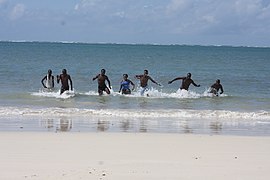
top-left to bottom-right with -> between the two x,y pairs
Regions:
0,0 -> 270,47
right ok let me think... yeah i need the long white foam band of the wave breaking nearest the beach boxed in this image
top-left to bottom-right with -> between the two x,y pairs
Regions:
0,107 -> 270,121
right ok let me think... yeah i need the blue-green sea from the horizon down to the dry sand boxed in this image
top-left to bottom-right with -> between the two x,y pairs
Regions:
0,42 -> 270,136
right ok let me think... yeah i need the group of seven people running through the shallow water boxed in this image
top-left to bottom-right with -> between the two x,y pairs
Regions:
41,69 -> 223,96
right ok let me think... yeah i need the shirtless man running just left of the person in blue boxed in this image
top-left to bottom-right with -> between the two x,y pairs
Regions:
93,69 -> 111,96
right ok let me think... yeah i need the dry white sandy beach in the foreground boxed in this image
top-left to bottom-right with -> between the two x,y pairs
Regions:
0,132 -> 270,180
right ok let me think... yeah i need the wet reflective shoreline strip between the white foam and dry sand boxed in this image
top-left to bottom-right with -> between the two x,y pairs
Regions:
0,116 -> 270,137
